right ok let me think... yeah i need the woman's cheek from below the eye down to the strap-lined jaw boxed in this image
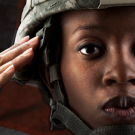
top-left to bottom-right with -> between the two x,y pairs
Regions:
61,53 -> 103,125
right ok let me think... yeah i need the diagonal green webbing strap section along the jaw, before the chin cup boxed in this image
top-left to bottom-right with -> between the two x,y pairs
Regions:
51,101 -> 91,135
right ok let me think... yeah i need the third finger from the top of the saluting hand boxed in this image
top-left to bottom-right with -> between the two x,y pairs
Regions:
0,48 -> 34,74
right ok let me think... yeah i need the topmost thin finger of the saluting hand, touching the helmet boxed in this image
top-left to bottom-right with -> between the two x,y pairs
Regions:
0,36 -> 30,55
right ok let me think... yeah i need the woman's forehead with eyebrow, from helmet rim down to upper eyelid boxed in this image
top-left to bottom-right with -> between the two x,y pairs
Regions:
61,7 -> 135,40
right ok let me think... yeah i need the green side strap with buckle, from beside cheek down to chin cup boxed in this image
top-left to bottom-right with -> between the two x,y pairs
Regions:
50,64 -> 91,135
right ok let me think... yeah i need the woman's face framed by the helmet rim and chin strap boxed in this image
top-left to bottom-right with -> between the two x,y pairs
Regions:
61,7 -> 135,128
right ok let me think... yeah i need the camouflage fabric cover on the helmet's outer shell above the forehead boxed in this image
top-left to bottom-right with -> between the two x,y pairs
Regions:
15,0 -> 135,42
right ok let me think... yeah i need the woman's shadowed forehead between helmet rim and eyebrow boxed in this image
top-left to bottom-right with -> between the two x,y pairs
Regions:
62,7 -> 135,26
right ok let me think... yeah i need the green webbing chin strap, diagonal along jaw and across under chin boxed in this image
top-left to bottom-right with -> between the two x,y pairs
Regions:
51,101 -> 135,135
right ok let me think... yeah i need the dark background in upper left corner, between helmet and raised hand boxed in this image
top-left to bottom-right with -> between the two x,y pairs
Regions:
0,0 -> 26,52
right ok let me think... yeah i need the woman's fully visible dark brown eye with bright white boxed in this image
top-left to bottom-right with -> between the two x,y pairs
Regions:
79,43 -> 104,55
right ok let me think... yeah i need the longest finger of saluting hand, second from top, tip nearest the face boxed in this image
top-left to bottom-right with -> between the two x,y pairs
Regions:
0,37 -> 39,65
